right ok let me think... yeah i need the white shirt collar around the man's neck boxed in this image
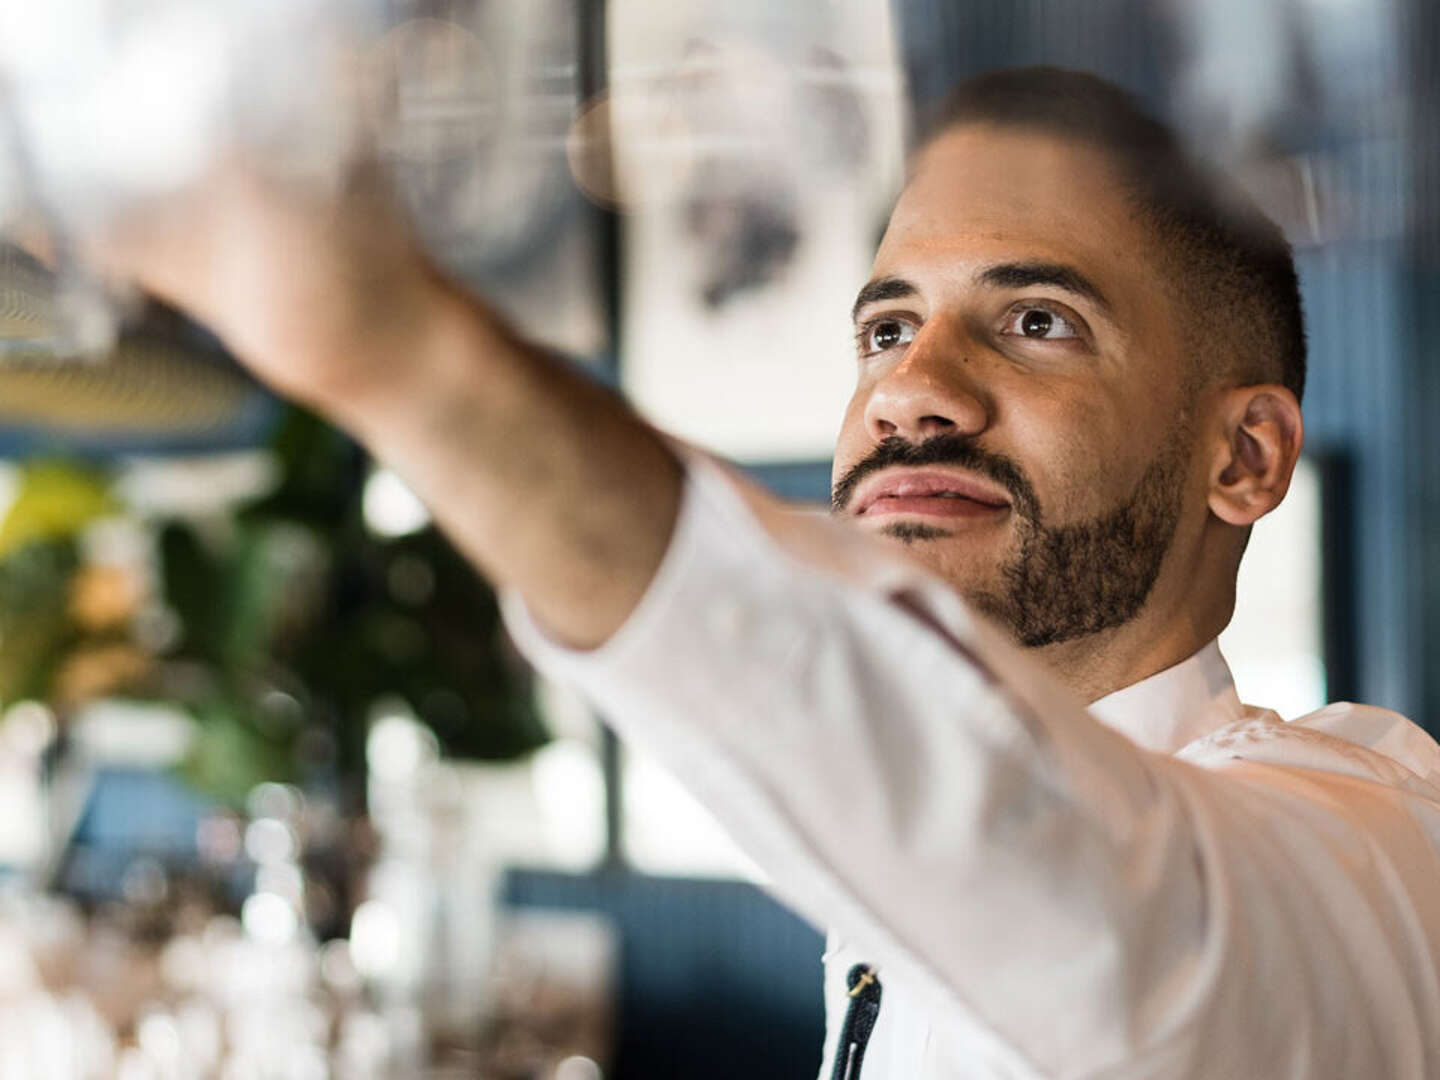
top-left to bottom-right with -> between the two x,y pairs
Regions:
1090,641 -> 1244,753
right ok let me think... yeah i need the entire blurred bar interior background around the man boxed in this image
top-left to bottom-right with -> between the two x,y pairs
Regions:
0,0 -> 1440,1080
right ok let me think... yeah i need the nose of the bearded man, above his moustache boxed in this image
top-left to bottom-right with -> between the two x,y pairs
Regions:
865,324 -> 992,442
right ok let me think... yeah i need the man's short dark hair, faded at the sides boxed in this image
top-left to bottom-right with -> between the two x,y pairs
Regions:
922,68 -> 1305,397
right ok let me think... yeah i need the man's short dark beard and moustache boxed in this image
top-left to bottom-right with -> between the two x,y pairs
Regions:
831,423 -> 1187,647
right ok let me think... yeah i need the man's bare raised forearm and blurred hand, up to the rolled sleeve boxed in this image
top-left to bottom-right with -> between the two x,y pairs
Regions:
80,168 -> 681,647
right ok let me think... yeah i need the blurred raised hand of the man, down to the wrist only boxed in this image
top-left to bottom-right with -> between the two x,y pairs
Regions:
82,161 -> 432,408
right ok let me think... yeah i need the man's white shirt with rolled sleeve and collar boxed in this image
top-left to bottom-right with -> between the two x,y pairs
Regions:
505,458 -> 1440,1080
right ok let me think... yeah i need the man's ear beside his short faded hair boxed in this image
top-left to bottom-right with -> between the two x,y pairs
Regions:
1210,384 -> 1305,526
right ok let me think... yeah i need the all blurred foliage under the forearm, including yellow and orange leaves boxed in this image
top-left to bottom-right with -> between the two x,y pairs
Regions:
0,410 -> 547,801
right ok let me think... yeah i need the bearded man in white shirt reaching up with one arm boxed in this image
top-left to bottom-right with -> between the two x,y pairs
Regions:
78,71 -> 1440,1080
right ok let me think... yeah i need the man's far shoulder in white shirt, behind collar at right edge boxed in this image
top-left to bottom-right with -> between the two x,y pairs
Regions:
1178,701 -> 1440,799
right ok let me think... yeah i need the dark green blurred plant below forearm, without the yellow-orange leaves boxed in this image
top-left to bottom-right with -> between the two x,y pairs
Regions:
160,410 -> 547,795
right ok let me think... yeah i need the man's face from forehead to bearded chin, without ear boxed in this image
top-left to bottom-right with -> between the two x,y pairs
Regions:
834,125 -> 1202,645
